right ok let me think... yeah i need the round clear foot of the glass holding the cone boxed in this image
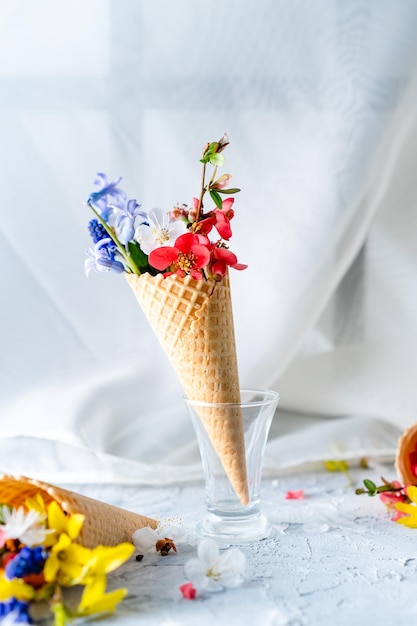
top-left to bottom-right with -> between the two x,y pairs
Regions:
196,512 -> 274,545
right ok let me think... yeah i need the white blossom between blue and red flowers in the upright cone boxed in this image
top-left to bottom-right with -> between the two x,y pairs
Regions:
135,209 -> 187,254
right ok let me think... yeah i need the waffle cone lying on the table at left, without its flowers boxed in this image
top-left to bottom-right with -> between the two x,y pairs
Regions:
0,474 -> 158,548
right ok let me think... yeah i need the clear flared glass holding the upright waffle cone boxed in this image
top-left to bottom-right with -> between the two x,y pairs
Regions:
184,389 -> 279,544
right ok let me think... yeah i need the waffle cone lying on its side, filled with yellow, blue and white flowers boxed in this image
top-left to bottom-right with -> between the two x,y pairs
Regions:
0,475 -> 157,626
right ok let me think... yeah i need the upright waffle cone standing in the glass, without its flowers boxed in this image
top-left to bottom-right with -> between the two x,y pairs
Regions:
126,274 -> 249,504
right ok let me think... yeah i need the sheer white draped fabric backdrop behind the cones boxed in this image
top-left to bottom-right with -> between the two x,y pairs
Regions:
0,0 -> 417,483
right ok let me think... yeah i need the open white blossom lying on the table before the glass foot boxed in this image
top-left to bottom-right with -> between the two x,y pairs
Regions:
184,539 -> 246,591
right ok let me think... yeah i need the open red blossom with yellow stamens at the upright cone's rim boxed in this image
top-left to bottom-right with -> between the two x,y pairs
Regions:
148,233 -> 210,280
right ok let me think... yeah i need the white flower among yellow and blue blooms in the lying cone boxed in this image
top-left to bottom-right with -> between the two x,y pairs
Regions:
0,506 -> 53,546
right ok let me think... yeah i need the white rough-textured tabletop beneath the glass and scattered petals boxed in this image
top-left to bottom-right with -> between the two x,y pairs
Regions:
52,467 -> 417,626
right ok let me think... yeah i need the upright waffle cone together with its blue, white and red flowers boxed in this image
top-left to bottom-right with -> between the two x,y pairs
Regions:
85,134 -> 248,504
